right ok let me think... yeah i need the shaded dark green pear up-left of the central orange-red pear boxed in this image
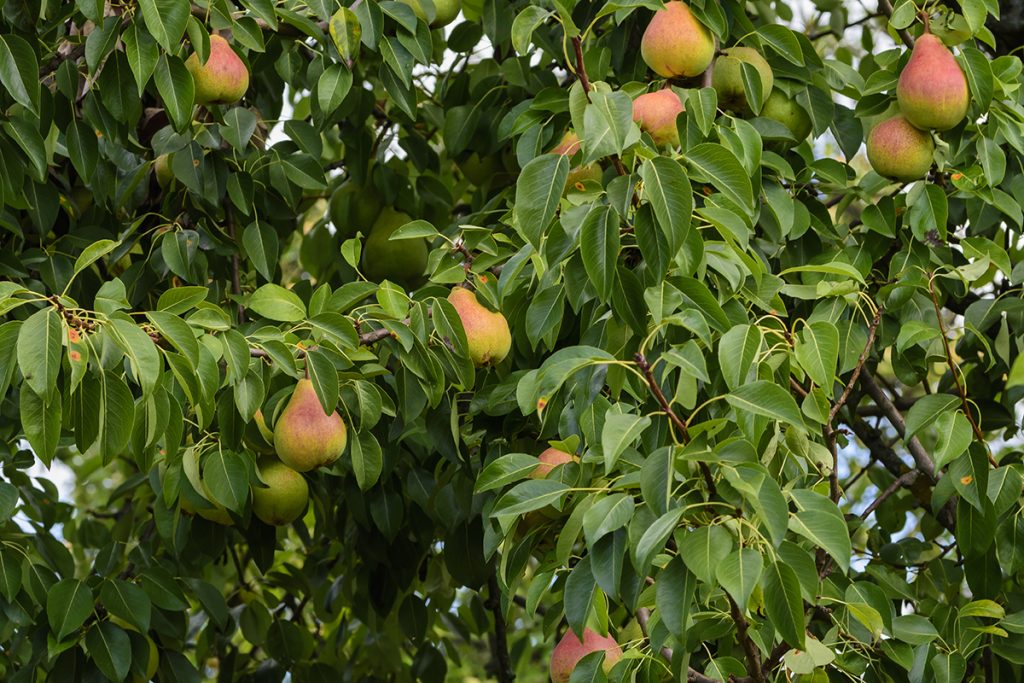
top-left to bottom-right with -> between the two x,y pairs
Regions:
362,208 -> 427,289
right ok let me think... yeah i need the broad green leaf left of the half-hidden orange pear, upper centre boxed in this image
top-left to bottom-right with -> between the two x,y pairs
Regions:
513,155 -> 569,250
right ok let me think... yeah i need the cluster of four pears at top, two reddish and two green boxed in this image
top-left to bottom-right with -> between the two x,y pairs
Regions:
633,0 -> 811,145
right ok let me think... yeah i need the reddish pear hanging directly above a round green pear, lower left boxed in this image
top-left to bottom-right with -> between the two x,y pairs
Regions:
273,379 -> 348,472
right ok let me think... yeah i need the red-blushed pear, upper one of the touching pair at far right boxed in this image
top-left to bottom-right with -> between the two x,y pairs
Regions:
896,33 -> 970,130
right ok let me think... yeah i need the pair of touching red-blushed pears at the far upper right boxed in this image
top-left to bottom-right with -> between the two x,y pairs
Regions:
867,27 -> 971,181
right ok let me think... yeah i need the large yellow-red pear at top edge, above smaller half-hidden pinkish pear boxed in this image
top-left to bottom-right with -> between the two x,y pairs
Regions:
640,0 -> 715,78
